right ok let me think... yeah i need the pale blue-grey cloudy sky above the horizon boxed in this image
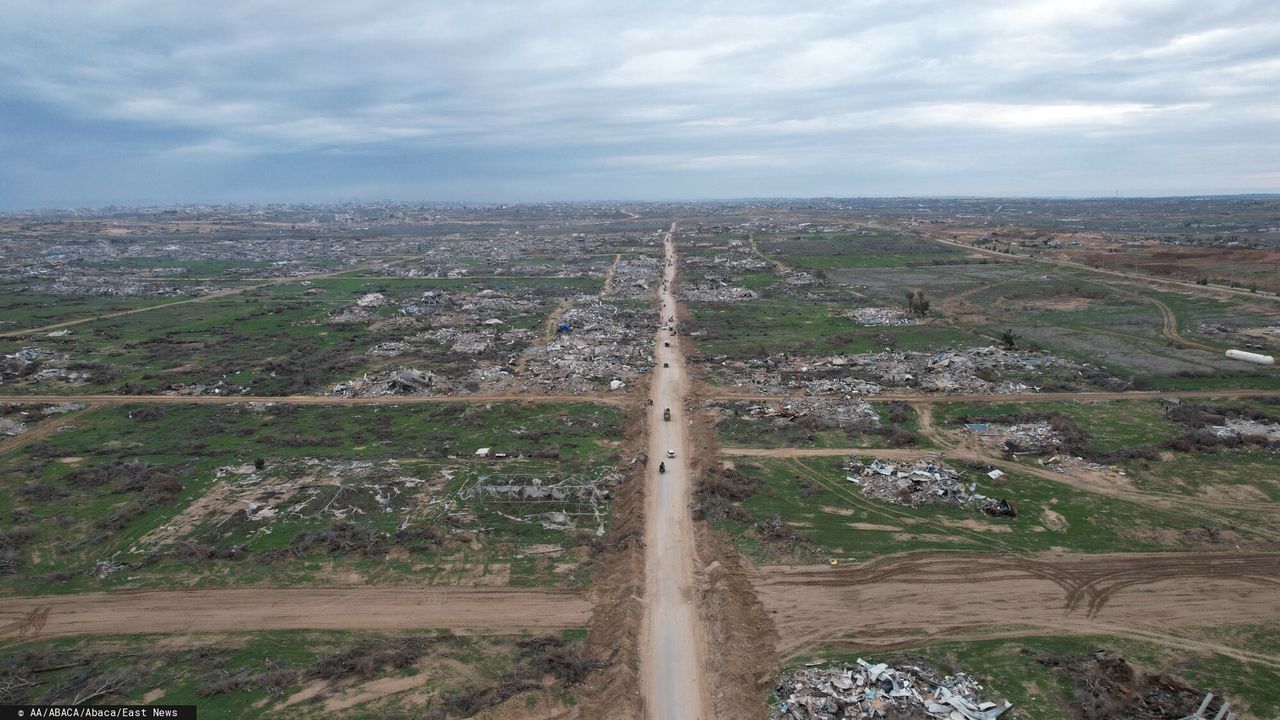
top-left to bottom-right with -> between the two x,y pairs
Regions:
0,0 -> 1280,209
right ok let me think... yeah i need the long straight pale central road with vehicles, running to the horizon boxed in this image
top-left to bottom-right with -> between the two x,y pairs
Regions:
640,224 -> 710,720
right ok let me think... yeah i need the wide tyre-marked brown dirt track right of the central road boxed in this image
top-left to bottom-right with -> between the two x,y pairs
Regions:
753,552 -> 1280,667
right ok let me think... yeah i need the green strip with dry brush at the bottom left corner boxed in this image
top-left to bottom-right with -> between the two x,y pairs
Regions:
0,630 -> 584,719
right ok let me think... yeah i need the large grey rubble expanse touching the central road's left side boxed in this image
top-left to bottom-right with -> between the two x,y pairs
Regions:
516,295 -> 653,393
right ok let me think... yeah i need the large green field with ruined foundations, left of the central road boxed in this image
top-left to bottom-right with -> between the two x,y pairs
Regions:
0,404 -> 621,594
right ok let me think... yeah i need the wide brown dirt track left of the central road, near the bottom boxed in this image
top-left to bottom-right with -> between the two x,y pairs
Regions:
0,587 -> 591,642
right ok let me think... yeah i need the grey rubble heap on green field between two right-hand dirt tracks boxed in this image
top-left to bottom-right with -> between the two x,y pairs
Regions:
845,457 -> 1016,518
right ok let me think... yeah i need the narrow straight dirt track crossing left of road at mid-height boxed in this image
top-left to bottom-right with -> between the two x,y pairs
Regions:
0,393 -> 627,405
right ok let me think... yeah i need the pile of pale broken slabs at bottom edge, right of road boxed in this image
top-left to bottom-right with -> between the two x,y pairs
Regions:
769,659 -> 1012,720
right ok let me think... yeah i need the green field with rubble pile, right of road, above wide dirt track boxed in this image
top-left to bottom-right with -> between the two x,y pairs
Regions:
718,454 -> 1262,564
